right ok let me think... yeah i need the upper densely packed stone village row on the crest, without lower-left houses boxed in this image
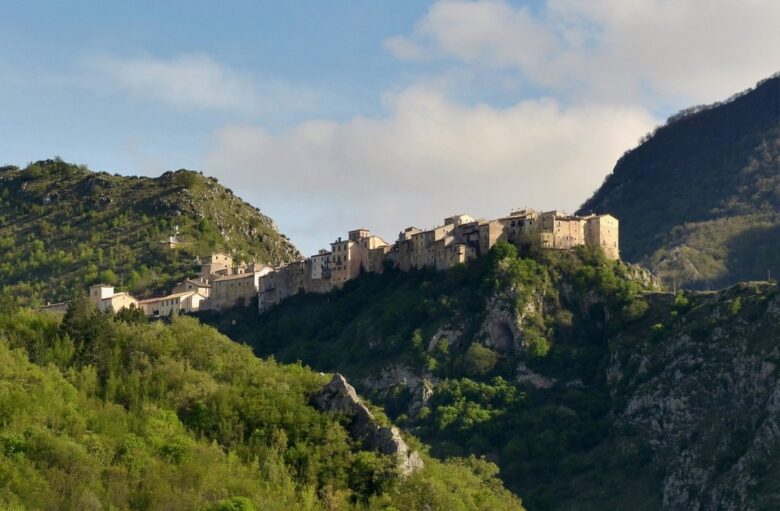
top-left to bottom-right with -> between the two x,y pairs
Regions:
257,208 -> 620,312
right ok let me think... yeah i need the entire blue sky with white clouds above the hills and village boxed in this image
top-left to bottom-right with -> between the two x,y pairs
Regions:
0,0 -> 780,254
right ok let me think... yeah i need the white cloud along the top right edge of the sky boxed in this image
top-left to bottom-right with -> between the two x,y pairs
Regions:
386,0 -> 780,102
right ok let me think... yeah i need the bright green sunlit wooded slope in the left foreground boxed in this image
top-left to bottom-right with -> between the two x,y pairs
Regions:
0,301 -> 521,511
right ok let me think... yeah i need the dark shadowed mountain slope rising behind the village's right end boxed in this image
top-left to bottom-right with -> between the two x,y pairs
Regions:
579,76 -> 780,287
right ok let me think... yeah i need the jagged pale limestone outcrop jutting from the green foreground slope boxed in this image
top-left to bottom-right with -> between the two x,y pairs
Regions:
312,373 -> 423,475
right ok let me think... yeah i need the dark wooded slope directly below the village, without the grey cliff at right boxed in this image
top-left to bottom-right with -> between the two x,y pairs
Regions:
202,243 -> 664,509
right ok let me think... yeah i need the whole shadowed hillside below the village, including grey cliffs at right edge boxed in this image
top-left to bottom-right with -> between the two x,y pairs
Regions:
203,243 -> 780,510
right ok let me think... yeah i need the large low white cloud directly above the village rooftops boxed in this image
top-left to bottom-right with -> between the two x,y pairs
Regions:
205,88 -> 654,251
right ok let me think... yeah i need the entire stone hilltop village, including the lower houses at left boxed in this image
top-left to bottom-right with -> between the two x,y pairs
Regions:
44,209 -> 620,317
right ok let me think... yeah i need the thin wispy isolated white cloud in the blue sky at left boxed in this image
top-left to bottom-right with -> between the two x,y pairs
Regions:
87,55 -> 317,113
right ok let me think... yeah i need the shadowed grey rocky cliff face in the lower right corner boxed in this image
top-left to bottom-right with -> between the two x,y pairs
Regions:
607,285 -> 780,510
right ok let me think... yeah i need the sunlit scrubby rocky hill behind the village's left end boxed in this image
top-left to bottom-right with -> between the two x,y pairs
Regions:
0,160 -> 297,305
